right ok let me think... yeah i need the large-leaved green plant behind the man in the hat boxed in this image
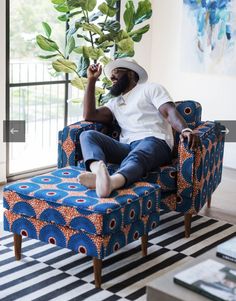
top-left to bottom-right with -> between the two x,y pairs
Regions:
36,0 -> 152,101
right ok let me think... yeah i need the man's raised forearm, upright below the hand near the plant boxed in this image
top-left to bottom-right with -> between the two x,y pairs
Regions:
83,78 -> 96,120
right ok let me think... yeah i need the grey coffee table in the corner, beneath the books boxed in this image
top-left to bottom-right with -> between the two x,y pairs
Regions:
147,248 -> 236,301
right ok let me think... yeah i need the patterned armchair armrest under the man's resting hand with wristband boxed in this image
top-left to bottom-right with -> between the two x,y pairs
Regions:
177,121 -> 225,214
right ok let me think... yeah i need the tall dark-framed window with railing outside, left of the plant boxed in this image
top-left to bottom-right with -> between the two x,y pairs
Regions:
7,0 -> 81,176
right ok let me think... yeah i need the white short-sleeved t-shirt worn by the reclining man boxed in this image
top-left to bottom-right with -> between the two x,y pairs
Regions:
105,82 -> 174,149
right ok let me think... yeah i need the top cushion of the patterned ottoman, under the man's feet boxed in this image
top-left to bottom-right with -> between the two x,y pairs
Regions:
4,167 -> 160,235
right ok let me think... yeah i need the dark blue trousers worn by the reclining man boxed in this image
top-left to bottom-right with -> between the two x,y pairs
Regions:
80,130 -> 172,186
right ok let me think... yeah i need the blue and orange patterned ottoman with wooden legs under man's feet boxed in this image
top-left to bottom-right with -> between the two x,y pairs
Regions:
4,167 -> 160,287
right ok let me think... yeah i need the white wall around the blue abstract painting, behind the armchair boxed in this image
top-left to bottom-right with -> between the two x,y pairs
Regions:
148,0 -> 236,168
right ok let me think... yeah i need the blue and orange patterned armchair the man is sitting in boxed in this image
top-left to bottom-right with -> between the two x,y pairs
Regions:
58,100 -> 225,237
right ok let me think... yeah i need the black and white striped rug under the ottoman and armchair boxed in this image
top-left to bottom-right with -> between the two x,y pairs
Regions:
0,212 -> 236,301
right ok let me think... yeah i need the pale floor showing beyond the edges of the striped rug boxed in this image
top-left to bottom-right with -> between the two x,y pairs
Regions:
0,168 -> 236,224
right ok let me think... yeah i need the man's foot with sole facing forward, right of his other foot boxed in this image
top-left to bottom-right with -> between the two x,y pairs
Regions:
96,161 -> 112,198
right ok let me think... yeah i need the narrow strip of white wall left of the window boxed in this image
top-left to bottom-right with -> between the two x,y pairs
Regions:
0,1 -> 6,182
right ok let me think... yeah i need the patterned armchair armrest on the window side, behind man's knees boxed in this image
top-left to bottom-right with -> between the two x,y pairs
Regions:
57,121 -> 106,168
